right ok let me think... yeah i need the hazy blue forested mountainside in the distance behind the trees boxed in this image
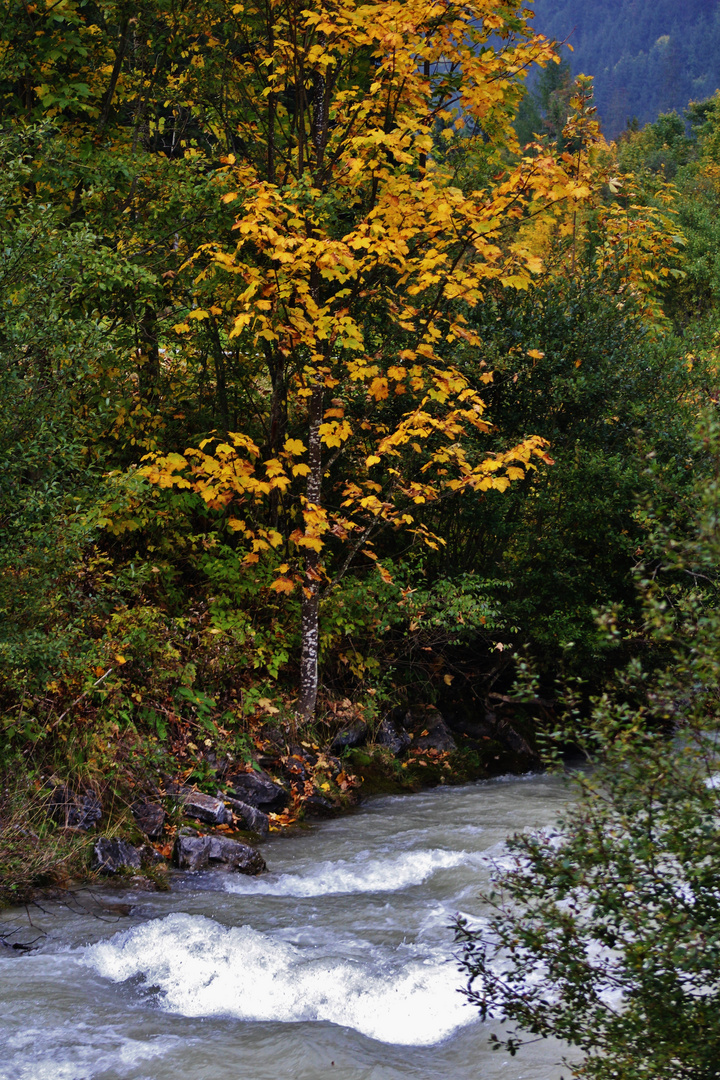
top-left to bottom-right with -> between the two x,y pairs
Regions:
533,0 -> 720,138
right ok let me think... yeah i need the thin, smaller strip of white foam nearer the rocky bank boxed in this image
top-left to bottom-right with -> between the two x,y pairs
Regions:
223,848 -> 475,897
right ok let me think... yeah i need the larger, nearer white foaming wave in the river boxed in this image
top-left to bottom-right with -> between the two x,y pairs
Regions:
82,914 -> 476,1047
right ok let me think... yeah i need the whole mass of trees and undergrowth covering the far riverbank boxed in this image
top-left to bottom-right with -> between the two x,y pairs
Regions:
0,0 -> 720,1036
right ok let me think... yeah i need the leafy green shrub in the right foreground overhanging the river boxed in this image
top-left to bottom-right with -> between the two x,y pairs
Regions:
457,421 -> 720,1080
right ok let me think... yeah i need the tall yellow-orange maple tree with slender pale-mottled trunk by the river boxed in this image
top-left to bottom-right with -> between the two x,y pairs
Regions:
134,0 -> 608,719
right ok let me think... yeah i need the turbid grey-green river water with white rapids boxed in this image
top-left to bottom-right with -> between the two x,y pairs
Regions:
0,775 -> 568,1080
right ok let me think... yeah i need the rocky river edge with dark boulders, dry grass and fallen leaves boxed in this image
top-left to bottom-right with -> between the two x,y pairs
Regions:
0,705 -> 539,904
